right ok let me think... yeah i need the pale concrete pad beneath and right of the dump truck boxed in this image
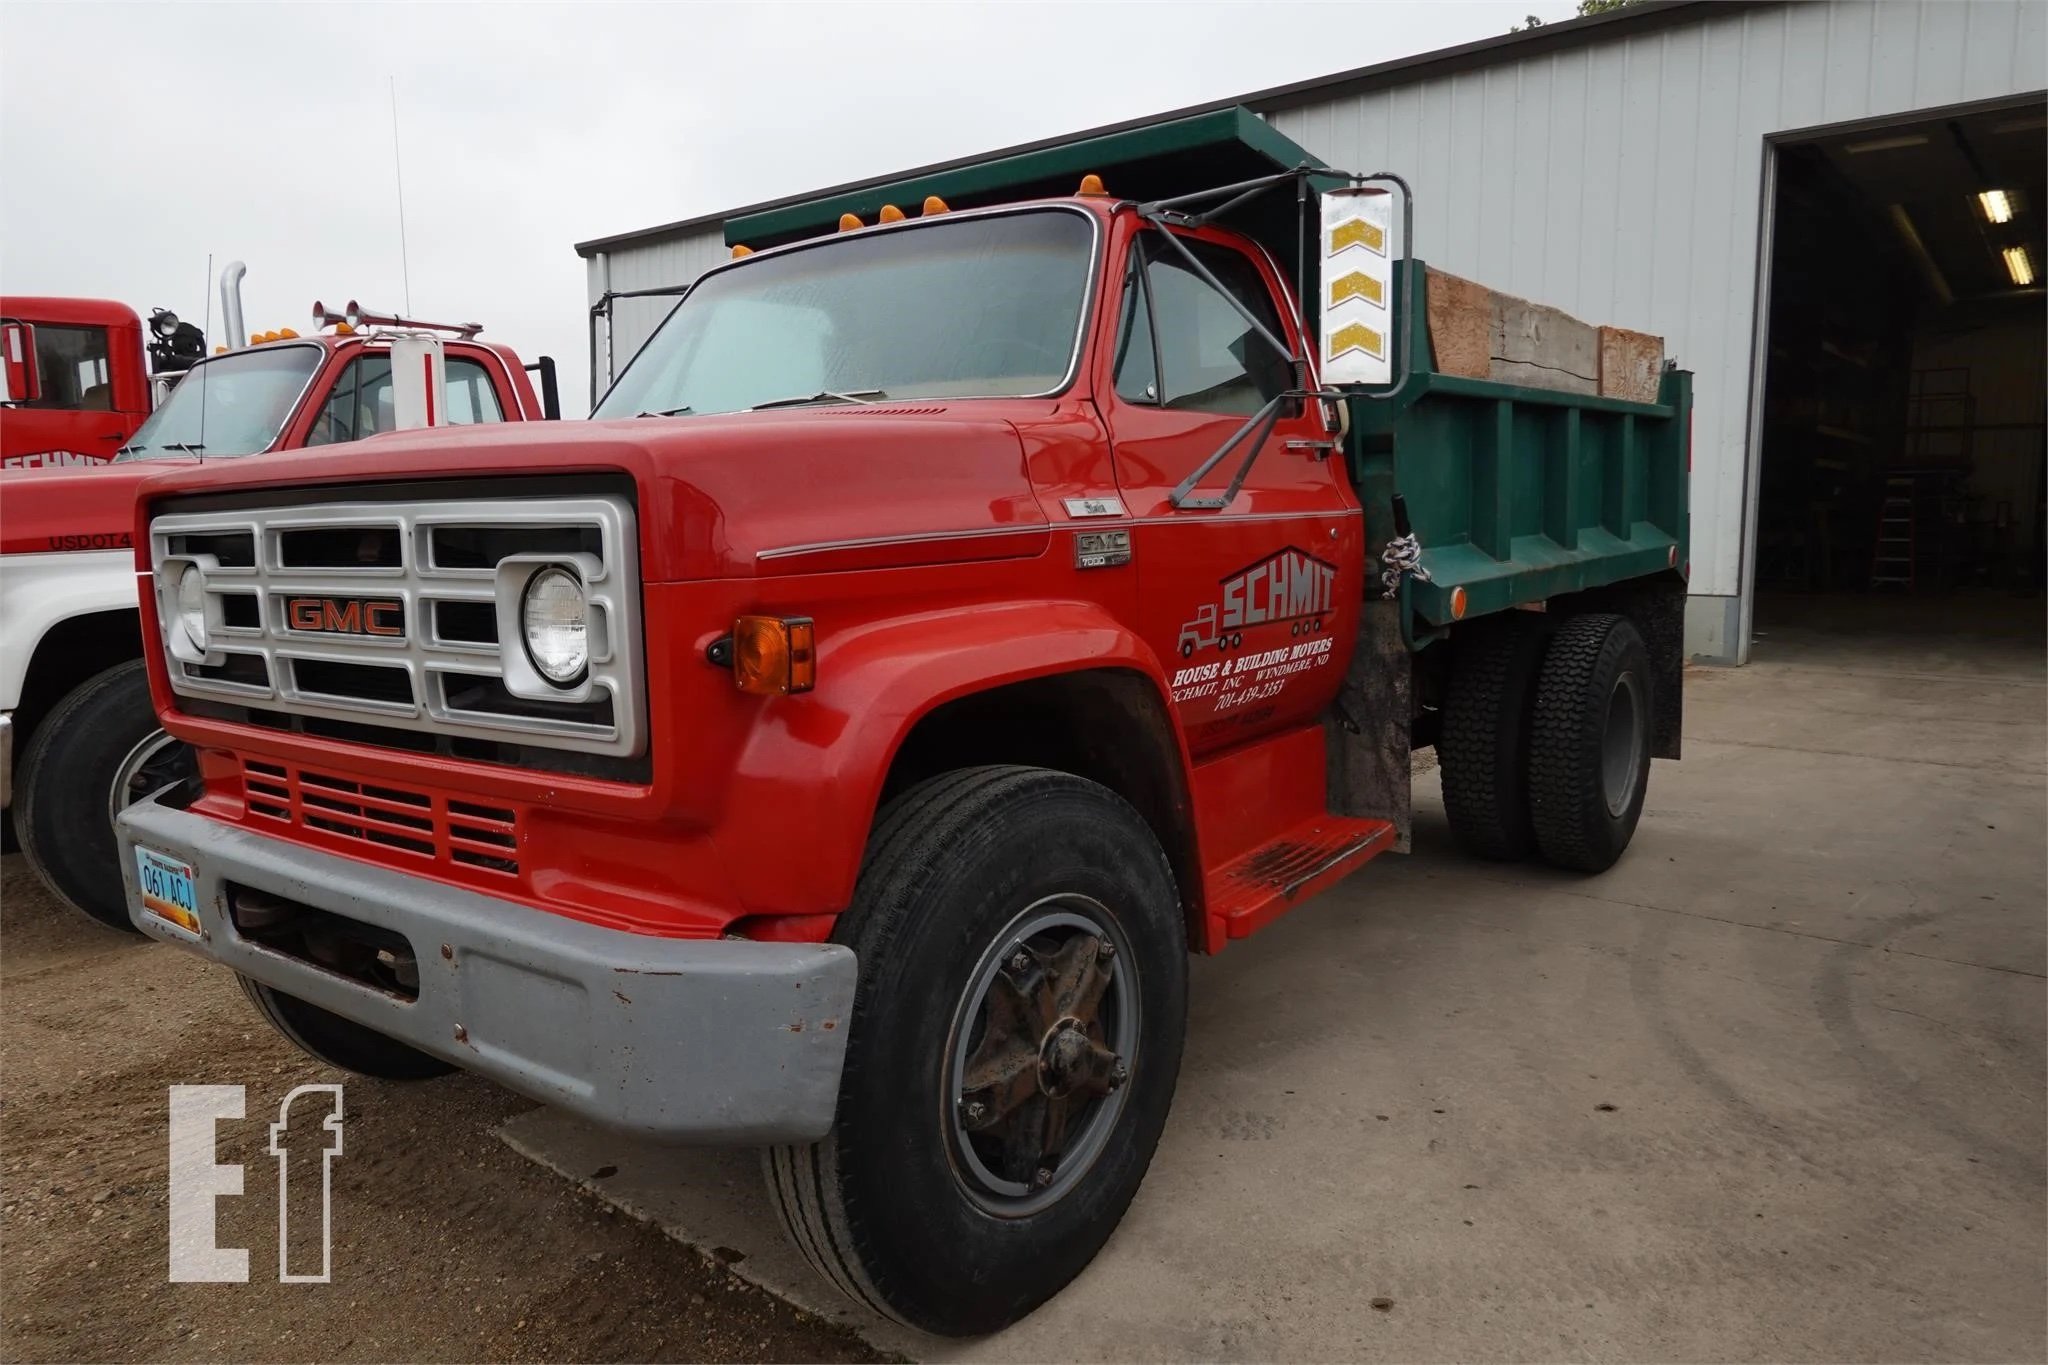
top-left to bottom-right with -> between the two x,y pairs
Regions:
504,626 -> 2048,1361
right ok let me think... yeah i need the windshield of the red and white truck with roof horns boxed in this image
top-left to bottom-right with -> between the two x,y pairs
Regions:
115,346 -> 322,460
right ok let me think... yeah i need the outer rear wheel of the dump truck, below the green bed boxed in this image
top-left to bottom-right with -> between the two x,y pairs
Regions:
1530,614 -> 1655,872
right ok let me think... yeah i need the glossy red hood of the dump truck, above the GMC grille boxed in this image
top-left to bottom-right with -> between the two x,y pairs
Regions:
139,401 -> 1053,581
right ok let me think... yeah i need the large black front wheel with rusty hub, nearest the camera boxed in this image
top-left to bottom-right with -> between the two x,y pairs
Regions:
764,767 -> 1188,1336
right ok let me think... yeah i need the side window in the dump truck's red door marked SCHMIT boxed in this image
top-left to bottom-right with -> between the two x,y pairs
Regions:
1116,233 -> 1292,415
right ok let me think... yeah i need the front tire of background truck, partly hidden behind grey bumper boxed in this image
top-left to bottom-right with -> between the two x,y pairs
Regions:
14,659 -> 195,933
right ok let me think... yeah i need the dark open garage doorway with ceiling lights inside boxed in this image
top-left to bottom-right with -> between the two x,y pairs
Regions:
1751,98 -> 2048,659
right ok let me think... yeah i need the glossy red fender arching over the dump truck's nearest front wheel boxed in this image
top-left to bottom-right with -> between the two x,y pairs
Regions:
715,602 -> 1188,915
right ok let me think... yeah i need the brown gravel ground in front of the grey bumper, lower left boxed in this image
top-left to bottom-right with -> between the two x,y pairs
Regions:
0,855 -> 883,1361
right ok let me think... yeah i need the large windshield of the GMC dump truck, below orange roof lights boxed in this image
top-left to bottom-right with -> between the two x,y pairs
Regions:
592,209 -> 1096,417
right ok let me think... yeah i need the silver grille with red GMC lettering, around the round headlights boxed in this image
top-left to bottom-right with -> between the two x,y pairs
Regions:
150,495 -> 645,755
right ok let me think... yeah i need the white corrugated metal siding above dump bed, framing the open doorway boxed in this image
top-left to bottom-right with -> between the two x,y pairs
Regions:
1272,0 -> 2048,596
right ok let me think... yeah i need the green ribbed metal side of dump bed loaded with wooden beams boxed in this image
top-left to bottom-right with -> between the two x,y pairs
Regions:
1348,270 -> 1692,645
